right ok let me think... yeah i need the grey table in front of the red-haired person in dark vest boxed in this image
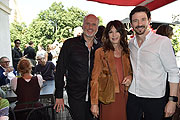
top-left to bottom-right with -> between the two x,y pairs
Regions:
6,80 -> 55,104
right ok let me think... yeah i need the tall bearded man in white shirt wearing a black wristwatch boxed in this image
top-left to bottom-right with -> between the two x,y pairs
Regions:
127,6 -> 179,120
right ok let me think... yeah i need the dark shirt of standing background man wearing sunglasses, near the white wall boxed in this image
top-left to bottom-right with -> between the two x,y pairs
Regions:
12,47 -> 22,71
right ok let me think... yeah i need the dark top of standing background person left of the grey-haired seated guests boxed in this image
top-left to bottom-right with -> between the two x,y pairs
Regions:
24,46 -> 36,60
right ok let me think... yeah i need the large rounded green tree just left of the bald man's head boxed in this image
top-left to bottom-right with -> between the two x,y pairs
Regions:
28,2 -> 87,47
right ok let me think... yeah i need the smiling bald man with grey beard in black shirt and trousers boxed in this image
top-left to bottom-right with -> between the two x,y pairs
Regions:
54,14 -> 100,120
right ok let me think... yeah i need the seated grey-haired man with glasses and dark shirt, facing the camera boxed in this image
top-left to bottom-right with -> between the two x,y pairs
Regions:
34,55 -> 55,80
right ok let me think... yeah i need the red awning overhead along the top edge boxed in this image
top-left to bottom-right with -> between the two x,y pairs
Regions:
87,0 -> 176,11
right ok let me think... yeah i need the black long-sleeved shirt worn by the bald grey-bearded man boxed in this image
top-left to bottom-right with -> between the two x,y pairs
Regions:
55,36 -> 100,101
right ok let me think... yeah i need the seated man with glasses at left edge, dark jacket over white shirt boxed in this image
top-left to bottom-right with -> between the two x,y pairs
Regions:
0,57 -> 16,86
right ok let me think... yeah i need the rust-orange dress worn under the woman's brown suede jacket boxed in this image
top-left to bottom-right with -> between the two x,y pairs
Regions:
100,57 -> 128,120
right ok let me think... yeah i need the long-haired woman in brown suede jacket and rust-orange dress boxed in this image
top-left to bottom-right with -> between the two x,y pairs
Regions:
90,20 -> 132,120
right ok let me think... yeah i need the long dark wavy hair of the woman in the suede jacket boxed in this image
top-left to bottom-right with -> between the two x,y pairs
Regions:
102,20 -> 129,54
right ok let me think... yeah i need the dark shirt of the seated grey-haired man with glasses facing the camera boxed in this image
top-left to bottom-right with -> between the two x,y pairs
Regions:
34,61 -> 55,80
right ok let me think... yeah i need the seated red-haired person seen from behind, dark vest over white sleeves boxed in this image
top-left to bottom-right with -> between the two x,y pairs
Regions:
11,58 -> 43,110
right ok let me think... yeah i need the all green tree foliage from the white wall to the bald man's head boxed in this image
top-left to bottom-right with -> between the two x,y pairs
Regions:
10,2 -> 102,49
